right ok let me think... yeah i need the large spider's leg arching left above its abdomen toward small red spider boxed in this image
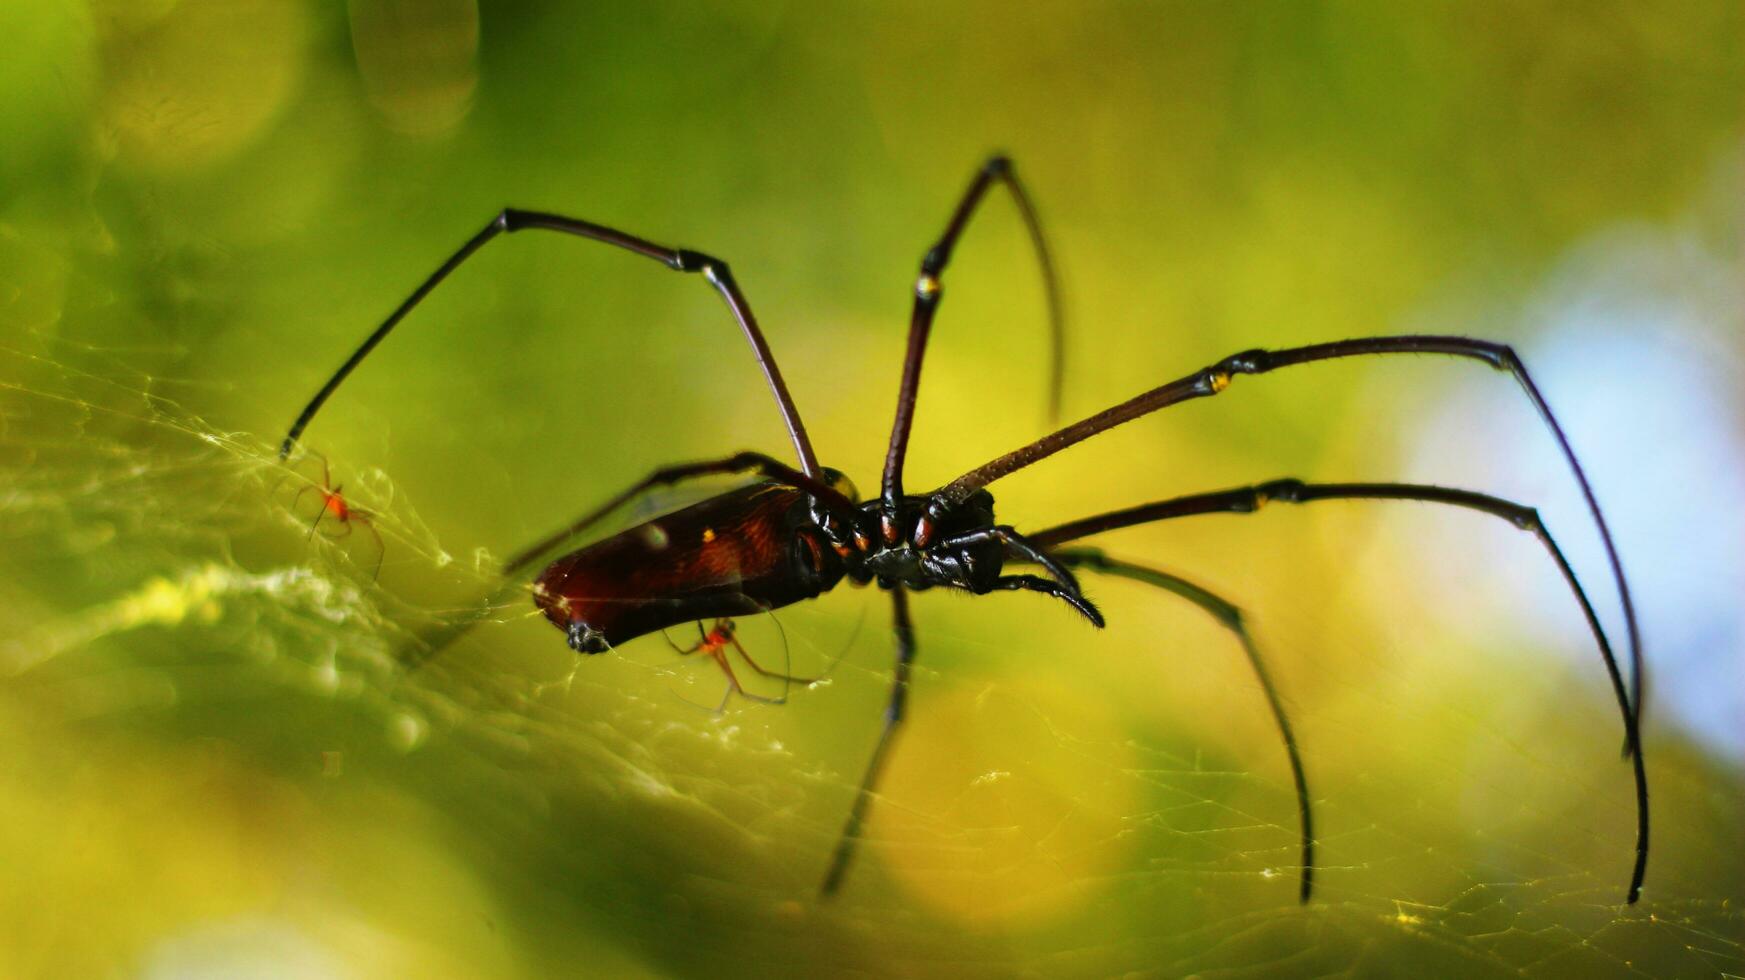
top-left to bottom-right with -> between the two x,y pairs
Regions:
279,208 -> 822,478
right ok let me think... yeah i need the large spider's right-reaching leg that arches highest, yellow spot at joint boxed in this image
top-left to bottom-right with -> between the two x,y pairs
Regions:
928,335 -> 1642,735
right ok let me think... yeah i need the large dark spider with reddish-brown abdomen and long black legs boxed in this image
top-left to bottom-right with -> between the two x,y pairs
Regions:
279,155 -> 1649,903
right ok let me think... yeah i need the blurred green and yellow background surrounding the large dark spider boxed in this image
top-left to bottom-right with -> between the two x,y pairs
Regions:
0,0 -> 1745,977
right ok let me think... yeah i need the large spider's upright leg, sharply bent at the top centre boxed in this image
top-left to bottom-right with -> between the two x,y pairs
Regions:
881,155 -> 1066,526
